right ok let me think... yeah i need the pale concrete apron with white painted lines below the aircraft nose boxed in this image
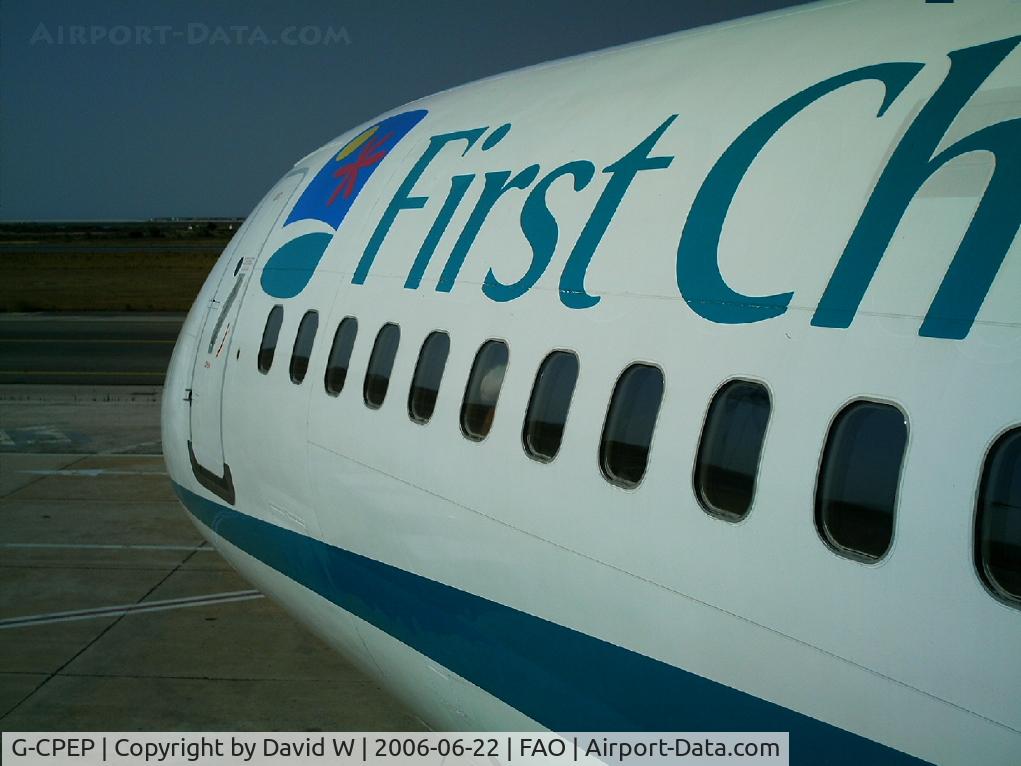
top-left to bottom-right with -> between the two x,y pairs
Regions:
0,385 -> 425,731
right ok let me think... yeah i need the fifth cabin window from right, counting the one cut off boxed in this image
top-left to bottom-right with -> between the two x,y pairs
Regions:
522,351 -> 578,462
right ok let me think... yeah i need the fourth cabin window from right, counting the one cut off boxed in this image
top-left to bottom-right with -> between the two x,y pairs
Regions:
599,365 -> 663,489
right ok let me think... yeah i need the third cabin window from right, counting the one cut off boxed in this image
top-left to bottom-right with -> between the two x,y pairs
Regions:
694,380 -> 770,521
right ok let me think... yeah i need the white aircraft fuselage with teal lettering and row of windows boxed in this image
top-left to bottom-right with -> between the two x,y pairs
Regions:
163,0 -> 1021,764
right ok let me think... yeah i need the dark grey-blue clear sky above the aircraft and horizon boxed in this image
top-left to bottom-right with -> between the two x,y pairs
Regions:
0,0 -> 804,221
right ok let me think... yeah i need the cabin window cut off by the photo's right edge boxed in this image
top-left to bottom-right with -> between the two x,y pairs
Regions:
975,428 -> 1021,607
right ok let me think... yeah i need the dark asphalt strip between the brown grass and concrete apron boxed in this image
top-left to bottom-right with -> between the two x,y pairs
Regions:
0,314 -> 184,385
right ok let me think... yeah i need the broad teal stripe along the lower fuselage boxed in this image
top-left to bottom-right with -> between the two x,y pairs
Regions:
174,483 -> 925,766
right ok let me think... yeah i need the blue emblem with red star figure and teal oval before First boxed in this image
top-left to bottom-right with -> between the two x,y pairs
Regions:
261,109 -> 427,298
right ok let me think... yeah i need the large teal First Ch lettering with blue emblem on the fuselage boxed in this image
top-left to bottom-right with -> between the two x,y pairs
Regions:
263,37 -> 1021,340
